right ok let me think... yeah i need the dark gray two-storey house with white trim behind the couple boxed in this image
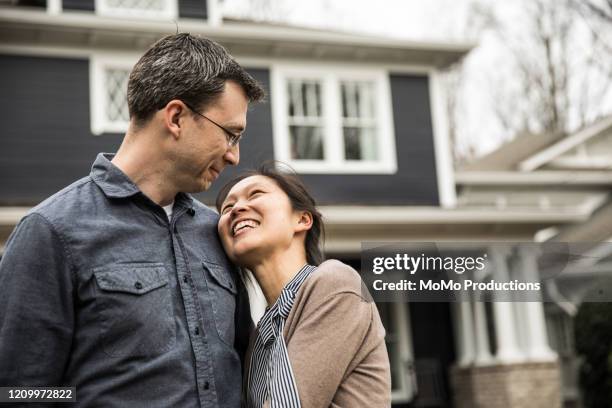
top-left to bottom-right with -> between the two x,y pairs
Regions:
0,0 -> 612,407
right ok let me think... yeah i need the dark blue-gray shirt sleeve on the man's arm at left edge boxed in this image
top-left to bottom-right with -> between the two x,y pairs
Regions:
0,214 -> 74,386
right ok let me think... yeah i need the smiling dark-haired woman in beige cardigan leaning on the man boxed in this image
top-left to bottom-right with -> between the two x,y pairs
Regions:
217,164 -> 391,408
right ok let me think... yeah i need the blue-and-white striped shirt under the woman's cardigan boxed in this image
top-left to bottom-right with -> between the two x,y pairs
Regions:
247,264 -> 316,408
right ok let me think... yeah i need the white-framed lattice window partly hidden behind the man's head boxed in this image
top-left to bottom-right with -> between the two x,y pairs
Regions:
89,55 -> 136,135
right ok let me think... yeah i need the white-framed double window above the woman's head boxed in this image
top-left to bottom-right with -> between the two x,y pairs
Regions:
272,66 -> 397,174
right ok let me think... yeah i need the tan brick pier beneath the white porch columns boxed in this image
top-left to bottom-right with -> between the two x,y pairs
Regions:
451,362 -> 561,408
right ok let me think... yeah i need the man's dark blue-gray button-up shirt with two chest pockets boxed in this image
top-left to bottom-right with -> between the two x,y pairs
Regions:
0,154 -> 241,407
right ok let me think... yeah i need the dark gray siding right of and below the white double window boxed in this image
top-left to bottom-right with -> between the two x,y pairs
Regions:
292,75 -> 438,205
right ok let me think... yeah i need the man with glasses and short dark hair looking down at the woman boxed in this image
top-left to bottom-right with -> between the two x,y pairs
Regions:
0,34 -> 263,407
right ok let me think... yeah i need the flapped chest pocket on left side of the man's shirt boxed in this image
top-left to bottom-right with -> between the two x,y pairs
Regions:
94,263 -> 176,357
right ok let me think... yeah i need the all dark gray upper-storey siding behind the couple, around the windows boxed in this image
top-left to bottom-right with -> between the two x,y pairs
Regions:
0,55 -> 438,205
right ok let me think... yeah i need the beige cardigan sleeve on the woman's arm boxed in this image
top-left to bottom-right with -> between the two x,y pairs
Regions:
287,292 -> 372,408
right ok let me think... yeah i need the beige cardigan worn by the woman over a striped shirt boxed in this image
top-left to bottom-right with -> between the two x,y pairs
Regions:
244,260 -> 391,408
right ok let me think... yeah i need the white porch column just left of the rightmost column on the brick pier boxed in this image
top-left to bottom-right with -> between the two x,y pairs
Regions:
489,248 -> 525,364
